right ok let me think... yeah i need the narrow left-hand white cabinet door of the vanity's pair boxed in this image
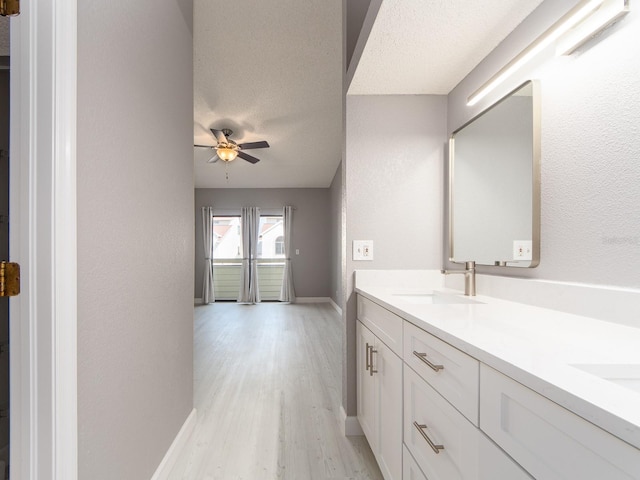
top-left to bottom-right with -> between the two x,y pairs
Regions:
356,322 -> 378,453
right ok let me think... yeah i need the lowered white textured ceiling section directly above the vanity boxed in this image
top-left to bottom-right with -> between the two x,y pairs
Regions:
349,0 -> 542,95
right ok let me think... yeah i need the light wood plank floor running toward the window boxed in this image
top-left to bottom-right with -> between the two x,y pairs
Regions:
170,303 -> 382,480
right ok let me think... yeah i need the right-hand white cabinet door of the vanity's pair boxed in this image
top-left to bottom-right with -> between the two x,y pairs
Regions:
373,339 -> 402,480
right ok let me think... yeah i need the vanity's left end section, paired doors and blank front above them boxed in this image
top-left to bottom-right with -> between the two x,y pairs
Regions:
356,297 -> 402,480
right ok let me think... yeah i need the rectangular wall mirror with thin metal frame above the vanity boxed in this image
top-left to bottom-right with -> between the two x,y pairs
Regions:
449,81 -> 540,267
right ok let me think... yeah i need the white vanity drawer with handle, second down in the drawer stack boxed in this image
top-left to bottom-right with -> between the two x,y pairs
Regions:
404,367 -> 480,480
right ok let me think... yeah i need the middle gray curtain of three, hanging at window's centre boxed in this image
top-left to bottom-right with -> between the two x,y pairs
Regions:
238,207 -> 260,303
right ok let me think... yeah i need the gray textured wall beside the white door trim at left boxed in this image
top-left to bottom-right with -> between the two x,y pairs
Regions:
77,0 -> 194,480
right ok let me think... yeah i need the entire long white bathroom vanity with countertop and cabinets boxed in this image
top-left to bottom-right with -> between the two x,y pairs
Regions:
356,271 -> 640,480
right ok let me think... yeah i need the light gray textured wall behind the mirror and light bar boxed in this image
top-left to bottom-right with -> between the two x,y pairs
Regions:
448,0 -> 640,288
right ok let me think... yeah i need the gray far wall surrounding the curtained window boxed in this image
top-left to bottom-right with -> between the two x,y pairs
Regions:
194,188 -> 331,298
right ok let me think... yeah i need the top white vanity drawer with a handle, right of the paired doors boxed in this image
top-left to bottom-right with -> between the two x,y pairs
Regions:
403,322 -> 480,425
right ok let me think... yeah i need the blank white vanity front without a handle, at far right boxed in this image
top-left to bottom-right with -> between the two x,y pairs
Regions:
480,365 -> 640,480
